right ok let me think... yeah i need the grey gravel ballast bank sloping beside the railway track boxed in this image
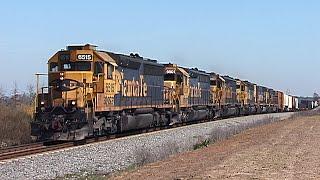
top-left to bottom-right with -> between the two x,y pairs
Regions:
0,113 -> 293,179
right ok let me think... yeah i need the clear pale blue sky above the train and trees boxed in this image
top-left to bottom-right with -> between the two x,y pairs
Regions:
0,0 -> 320,95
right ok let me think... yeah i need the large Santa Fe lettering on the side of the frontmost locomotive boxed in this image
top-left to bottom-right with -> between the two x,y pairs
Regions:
122,76 -> 148,97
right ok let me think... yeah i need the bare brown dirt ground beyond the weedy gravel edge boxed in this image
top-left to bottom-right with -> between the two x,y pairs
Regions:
113,112 -> 320,179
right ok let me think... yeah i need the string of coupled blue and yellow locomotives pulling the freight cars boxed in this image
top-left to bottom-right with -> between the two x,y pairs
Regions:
31,44 -> 292,141
